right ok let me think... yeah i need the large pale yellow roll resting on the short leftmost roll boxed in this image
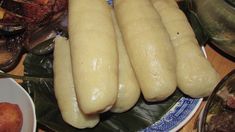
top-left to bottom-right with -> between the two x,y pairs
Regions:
68,0 -> 118,114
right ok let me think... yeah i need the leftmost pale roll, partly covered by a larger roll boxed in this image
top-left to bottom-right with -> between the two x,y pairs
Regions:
53,36 -> 99,128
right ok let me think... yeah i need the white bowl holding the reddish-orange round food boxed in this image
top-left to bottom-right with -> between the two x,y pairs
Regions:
0,78 -> 37,132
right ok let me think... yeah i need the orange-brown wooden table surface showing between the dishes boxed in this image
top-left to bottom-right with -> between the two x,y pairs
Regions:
6,45 -> 235,132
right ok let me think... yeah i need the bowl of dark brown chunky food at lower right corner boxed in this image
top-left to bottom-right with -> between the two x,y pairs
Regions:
198,70 -> 235,132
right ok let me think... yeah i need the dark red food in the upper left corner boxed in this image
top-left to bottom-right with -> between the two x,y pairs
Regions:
0,0 -> 68,27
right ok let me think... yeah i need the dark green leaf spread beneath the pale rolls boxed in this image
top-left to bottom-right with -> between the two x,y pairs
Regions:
19,3 -> 207,132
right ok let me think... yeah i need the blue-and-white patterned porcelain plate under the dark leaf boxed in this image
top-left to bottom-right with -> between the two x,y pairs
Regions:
107,0 -> 203,132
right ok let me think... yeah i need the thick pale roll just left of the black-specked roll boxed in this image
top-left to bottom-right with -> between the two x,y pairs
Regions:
114,0 -> 176,102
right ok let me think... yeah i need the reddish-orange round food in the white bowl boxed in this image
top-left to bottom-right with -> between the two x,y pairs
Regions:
0,102 -> 23,132
